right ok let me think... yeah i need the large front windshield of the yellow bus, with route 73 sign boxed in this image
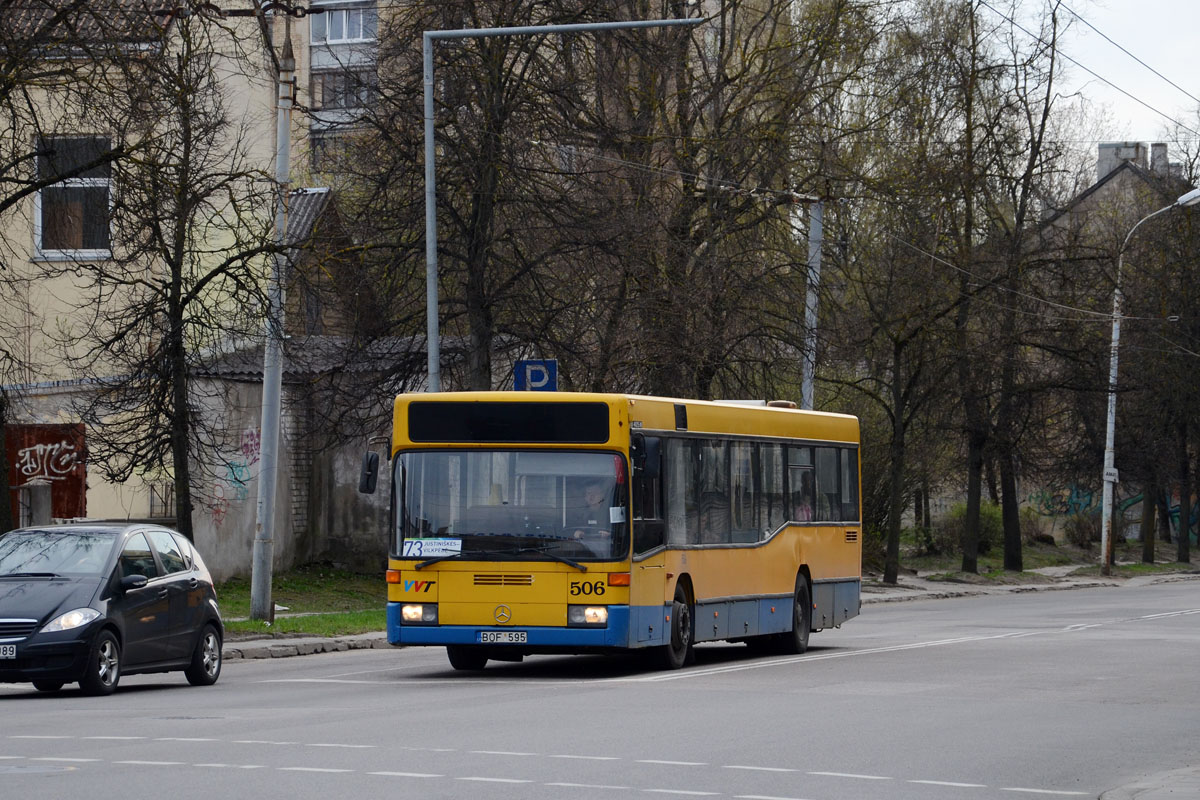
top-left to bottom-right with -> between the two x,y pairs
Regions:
394,450 -> 629,560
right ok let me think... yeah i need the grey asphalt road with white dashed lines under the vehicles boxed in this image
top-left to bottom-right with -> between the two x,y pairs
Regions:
0,581 -> 1200,800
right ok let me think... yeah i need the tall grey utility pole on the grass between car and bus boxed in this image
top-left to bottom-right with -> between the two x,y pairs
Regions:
250,28 -> 295,621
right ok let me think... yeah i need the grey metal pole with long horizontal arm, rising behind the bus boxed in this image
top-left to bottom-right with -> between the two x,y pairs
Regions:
421,17 -> 707,392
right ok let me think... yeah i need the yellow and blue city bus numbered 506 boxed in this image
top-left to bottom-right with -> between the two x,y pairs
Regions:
360,392 -> 862,669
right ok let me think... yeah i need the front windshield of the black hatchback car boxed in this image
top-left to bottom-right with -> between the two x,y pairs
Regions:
0,530 -> 116,578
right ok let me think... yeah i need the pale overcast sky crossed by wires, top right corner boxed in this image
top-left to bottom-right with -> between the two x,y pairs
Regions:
1062,0 -> 1200,142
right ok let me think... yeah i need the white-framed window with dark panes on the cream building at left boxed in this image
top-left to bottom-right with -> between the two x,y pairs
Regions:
34,137 -> 112,258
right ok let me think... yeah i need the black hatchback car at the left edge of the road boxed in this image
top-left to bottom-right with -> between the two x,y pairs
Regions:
0,523 -> 224,694
